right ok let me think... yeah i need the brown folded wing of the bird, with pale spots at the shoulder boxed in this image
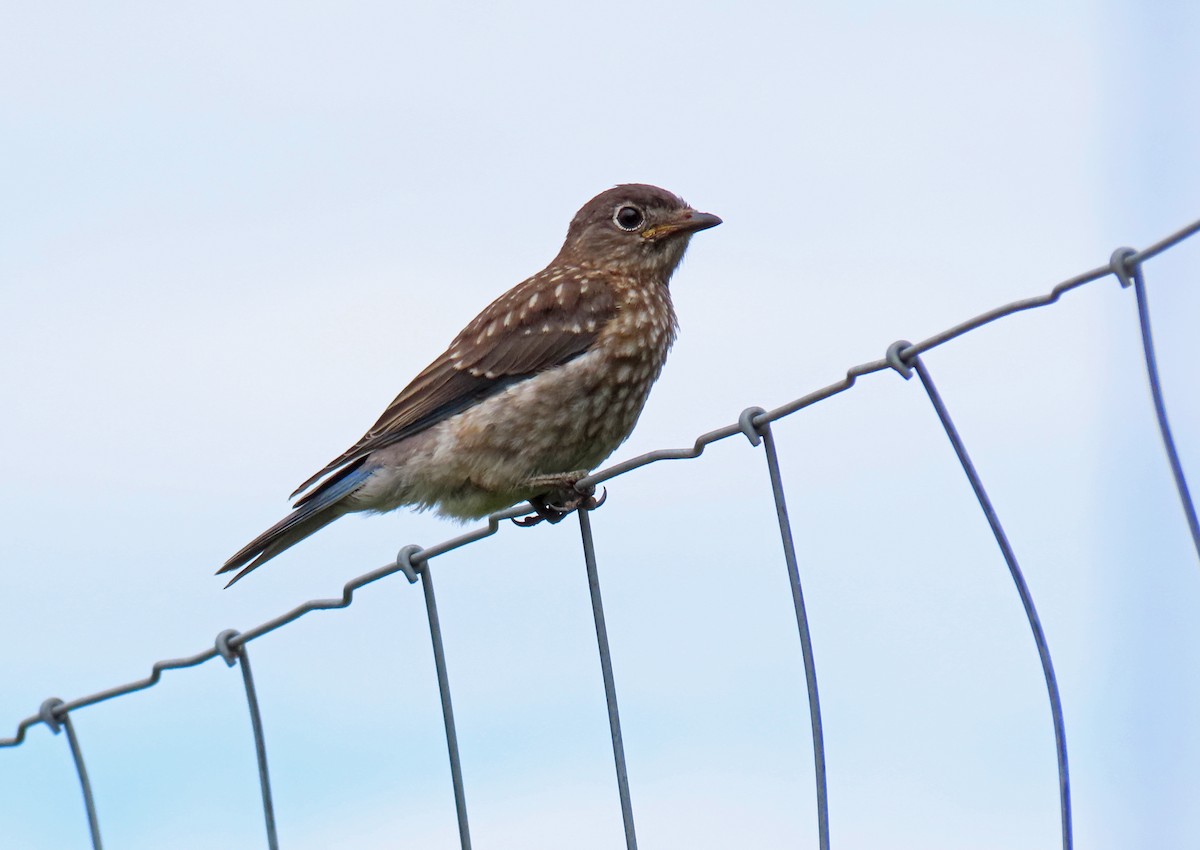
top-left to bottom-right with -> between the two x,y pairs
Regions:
292,269 -> 617,502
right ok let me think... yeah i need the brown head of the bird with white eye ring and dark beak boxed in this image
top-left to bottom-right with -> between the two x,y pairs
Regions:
558,182 -> 721,280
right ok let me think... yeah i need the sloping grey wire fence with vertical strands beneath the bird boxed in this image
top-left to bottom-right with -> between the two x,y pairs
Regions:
7,221 -> 1200,850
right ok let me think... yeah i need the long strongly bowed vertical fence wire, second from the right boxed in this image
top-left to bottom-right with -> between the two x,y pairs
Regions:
889,350 -> 1074,850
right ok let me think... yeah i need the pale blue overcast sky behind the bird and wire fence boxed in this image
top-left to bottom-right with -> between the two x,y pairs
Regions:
0,0 -> 1200,850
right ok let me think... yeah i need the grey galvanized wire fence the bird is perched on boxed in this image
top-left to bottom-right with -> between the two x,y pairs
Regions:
0,213 -> 1200,849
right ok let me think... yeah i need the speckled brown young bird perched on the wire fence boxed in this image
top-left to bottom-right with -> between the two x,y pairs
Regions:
217,184 -> 721,587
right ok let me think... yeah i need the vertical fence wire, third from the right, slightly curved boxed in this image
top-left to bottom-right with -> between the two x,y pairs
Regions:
743,408 -> 829,850
